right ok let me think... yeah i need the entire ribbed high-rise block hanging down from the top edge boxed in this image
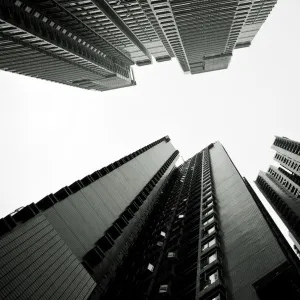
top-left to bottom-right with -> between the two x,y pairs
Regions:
0,0 -> 277,91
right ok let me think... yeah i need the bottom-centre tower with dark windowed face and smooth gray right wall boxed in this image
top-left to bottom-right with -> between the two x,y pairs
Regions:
100,143 -> 299,300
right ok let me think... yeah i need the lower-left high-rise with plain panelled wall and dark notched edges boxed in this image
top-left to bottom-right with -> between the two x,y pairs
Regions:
0,137 -> 178,300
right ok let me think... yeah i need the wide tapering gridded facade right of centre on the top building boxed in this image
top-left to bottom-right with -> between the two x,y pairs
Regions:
172,0 -> 237,74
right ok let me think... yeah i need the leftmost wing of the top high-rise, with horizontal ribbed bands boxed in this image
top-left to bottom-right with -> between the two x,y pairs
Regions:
0,0 -> 135,90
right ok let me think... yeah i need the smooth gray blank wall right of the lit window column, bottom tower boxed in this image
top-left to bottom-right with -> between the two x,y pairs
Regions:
210,143 -> 286,300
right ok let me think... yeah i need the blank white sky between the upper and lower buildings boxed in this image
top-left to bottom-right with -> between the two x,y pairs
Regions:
0,0 -> 300,217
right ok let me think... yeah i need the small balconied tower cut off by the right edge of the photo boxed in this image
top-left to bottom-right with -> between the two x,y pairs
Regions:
256,137 -> 300,247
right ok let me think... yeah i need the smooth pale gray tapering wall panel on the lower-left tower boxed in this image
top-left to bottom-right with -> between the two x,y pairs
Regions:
43,141 -> 175,259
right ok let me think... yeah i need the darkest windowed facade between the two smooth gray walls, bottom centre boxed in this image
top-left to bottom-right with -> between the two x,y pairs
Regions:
98,153 -> 204,299
